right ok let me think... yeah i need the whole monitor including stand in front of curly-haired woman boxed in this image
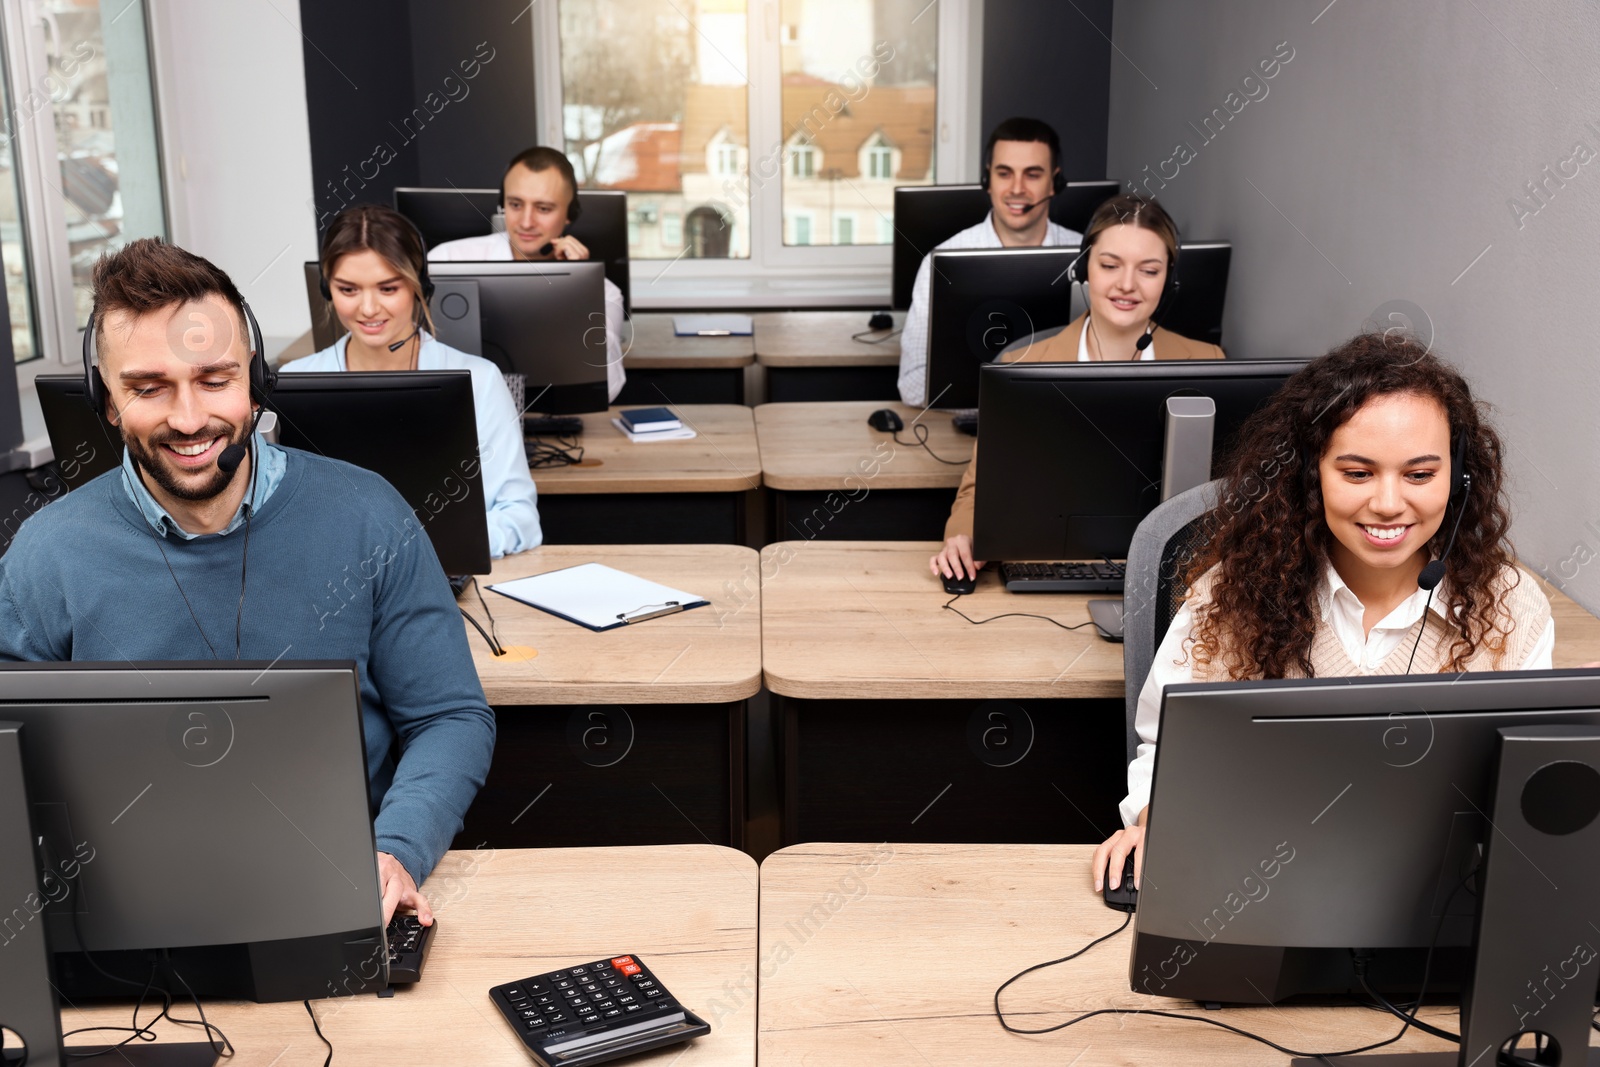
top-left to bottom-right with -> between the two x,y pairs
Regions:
1130,671 -> 1600,1064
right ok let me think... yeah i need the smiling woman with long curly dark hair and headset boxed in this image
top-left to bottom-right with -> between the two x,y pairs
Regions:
1093,334 -> 1555,889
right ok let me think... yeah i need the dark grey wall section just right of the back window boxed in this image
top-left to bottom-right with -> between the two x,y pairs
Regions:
979,0 -> 1122,181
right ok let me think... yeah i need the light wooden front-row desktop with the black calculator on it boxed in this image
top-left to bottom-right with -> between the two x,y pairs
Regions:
62,845 -> 757,1067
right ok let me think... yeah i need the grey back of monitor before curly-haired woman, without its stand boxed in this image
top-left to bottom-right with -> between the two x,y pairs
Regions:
1131,671 -> 1600,1003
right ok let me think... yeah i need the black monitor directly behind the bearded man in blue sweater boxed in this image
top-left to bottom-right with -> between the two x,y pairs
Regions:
35,371 -> 491,574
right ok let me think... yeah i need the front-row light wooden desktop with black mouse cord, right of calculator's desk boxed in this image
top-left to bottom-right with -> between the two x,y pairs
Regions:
758,845 -> 1456,1067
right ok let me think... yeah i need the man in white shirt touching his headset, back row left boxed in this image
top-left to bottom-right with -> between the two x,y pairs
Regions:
427,146 -> 626,400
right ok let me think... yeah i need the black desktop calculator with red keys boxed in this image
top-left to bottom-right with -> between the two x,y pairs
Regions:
490,955 -> 710,1067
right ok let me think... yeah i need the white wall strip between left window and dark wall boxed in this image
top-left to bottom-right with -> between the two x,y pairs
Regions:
150,0 -> 317,352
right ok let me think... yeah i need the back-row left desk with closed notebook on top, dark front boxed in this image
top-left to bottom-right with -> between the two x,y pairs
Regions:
618,310 -> 755,406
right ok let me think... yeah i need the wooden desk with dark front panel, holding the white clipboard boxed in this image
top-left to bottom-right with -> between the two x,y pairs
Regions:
456,547 -> 762,848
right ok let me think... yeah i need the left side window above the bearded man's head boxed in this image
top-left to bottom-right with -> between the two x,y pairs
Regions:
0,0 -> 166,370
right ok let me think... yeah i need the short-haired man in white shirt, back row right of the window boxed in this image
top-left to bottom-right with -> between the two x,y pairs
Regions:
899,118 -> 1083,405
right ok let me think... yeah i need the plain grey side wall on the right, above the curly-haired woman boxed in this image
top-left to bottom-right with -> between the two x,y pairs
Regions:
1107,0 -> 1600,611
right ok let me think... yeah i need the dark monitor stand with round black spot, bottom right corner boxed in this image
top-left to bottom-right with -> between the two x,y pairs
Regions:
1293,726 -> 1600,1067
